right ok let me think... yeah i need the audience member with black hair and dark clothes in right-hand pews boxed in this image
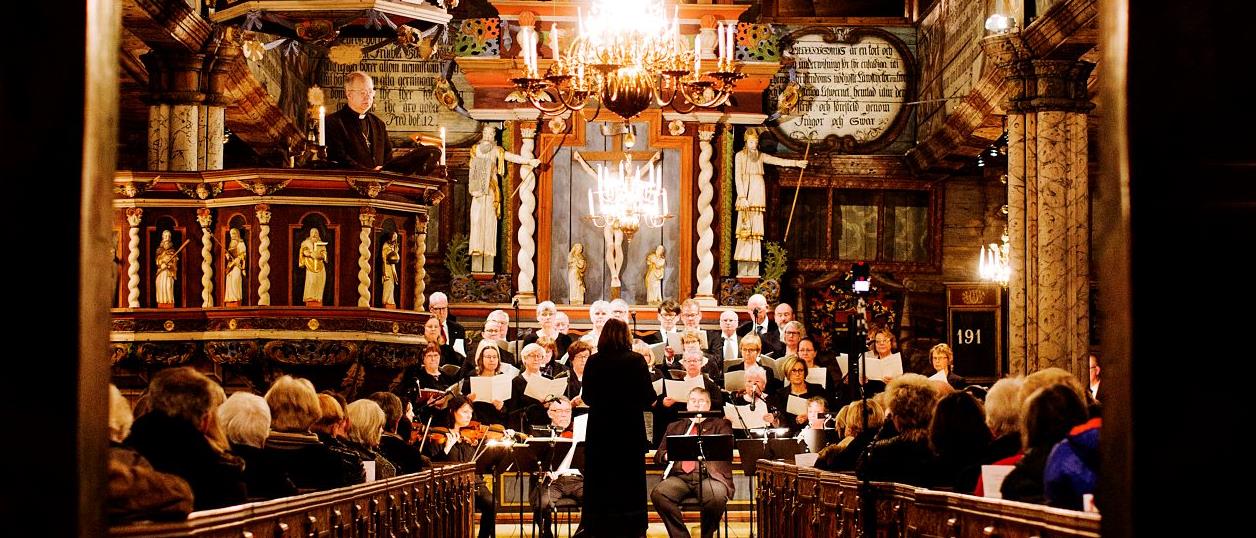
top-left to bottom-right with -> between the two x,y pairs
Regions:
929,392 -> 993,493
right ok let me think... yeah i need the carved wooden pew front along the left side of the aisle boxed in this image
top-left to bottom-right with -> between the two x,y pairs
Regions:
109,464 -> 476,538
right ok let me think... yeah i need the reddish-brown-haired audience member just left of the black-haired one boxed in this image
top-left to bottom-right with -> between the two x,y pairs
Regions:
855,373 -> 937,488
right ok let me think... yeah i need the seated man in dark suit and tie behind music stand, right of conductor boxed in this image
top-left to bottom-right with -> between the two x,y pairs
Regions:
649,387 -> 734,538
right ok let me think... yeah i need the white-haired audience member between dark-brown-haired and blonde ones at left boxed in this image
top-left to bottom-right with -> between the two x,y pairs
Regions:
217,391 -> 298,500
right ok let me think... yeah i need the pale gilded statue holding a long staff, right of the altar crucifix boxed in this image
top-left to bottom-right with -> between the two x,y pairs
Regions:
732,131 -> 806,277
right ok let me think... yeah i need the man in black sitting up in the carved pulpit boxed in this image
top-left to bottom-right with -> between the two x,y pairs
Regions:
324,70 -> 392,170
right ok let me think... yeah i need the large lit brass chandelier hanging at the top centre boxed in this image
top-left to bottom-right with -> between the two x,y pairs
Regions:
511,0 -> 745,121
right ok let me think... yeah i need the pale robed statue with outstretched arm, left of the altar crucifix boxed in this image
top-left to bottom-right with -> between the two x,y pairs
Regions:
467,124 -> 541,273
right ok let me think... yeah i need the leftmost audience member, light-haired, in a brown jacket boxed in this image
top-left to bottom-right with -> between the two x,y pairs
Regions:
104,385 -> 192,525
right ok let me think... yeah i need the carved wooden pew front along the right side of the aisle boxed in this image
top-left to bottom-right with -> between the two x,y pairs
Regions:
756,461 -> 1099,538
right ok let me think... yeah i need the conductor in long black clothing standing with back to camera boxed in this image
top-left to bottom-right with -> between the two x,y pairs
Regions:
580,319 -> 654,538
